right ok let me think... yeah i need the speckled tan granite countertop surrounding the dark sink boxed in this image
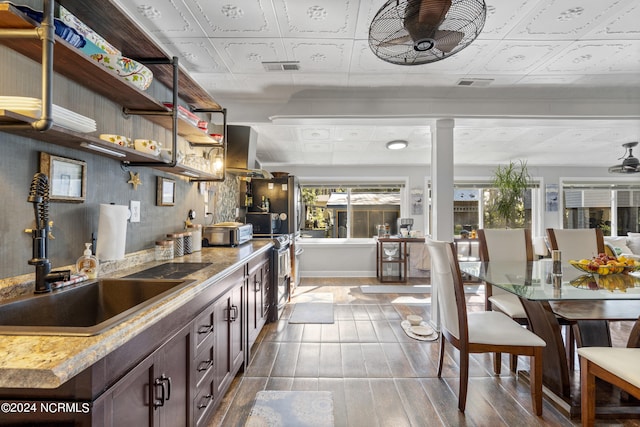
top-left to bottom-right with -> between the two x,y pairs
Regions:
0,240 -> 272,388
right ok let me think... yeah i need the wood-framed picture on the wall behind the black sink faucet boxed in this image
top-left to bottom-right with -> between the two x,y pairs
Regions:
40,152 -> 87,203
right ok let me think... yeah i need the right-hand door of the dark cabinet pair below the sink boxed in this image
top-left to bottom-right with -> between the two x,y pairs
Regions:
154,327 -> 191,427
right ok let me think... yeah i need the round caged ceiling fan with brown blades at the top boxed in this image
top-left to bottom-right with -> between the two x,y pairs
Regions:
369,0 -> 486,65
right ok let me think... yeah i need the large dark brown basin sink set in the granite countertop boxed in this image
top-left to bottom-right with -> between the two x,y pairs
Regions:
0,278 -> 194,336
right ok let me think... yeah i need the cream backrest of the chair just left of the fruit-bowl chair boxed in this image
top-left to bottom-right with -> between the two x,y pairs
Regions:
478,228 -> 533,261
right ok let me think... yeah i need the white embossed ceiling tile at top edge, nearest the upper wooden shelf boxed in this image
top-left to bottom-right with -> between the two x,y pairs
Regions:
116,0 -> 204,40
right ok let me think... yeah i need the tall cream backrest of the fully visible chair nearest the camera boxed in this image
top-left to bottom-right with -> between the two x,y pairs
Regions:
425,238 -> 469,342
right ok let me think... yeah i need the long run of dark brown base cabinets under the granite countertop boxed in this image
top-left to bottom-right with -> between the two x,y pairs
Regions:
0,247 -> 270,427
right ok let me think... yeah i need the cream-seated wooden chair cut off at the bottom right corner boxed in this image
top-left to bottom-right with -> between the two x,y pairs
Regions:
578,347 -> 640,426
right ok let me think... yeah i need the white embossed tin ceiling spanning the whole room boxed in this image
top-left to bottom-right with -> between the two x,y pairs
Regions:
112,0 -> 640,171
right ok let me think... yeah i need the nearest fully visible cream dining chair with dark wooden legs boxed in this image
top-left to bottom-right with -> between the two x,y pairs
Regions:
426,238 -> 546,415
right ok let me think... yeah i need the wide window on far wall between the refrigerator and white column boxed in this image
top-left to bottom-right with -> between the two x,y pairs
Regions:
301,184 -> 403,239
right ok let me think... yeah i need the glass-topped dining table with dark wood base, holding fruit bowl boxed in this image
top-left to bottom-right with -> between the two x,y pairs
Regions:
459,259 -> 640,416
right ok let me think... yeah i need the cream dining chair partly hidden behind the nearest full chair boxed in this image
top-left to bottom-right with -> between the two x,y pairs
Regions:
478,228 -> 534,374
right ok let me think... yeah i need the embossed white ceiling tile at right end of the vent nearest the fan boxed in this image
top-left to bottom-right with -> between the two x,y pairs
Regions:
284,39 -> 353,73
